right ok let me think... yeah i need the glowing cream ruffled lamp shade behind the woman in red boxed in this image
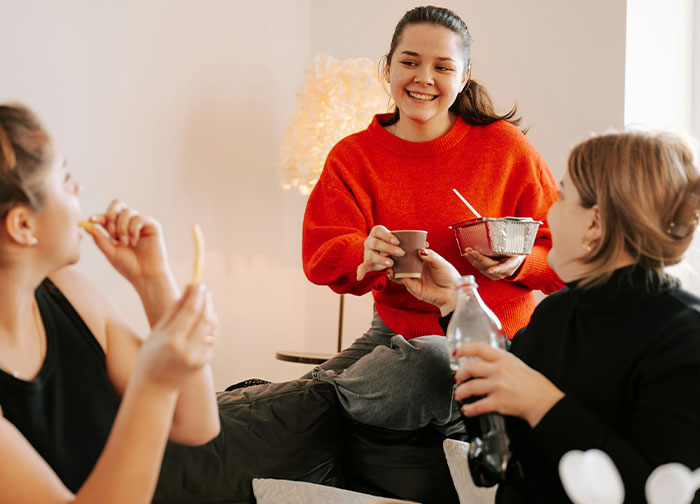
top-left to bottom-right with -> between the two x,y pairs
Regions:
278,53 -> 389,194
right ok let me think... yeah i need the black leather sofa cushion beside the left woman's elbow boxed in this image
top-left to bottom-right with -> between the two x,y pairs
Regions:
153,380 -> 343,504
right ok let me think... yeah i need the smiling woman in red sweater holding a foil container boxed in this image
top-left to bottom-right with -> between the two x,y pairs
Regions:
302,7 -> 563,370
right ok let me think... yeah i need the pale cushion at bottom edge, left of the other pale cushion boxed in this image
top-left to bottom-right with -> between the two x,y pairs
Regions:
253,478 -> 416,504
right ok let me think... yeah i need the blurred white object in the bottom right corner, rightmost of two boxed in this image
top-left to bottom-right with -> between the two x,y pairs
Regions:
645,463 -> 700,504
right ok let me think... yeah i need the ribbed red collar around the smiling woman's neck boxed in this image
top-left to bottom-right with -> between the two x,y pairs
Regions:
367,114 -> 471,157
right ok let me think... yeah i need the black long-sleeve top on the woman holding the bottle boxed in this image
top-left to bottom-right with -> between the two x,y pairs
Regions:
441,267 -> 700,503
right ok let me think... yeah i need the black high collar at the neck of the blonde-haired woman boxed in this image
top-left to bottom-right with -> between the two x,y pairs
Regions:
566,265 -> 679,313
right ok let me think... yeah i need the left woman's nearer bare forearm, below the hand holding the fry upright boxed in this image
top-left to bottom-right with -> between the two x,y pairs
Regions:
75,376 -> 177,504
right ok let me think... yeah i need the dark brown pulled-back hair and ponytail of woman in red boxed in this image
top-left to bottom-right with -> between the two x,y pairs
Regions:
379,5 -> 527,133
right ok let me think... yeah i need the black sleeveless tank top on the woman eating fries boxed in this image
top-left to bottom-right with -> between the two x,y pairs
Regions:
0,279 -> 120,492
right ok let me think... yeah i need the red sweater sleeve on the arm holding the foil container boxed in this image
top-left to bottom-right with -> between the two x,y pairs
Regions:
508,140 -> 564,294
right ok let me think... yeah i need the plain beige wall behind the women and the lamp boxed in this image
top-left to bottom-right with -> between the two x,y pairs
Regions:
0,0 -> 625,388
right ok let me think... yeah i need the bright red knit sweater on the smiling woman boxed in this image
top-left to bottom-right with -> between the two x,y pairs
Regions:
302,114 -> 563,338
